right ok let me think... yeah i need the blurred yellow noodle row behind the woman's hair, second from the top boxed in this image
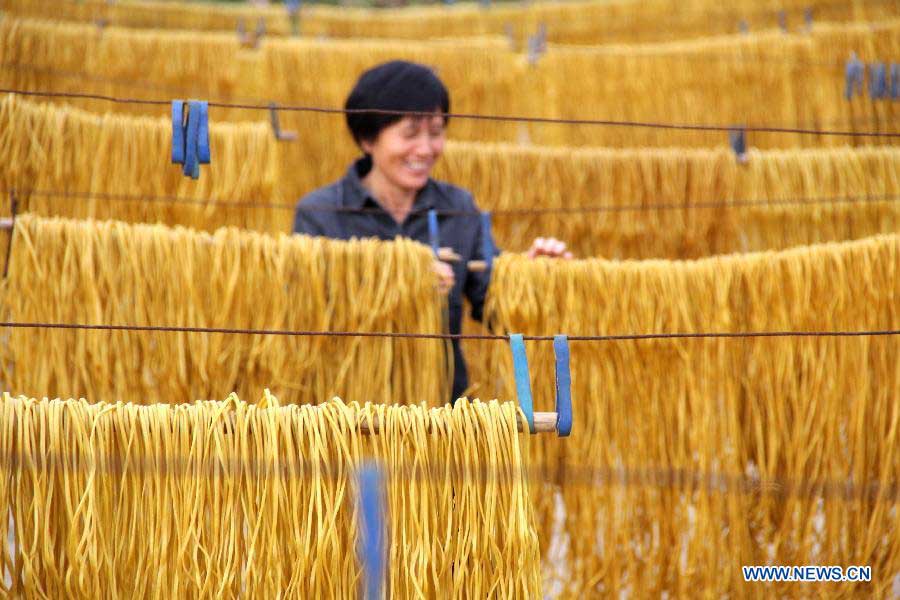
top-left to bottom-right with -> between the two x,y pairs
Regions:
0,18 -> 900,150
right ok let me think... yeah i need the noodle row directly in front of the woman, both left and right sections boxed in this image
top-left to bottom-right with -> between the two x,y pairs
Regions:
3,215 -> 900,597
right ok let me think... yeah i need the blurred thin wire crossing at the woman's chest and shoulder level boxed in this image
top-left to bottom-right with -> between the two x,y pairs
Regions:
7,188 -> 900,217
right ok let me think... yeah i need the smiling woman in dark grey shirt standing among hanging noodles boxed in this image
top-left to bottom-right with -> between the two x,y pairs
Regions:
294,61 -> 571,400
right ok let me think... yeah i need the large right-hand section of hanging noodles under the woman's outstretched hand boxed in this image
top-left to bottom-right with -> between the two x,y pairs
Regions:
468,234 -> 900,597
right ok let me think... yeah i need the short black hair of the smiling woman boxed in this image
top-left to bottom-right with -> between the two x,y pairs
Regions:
344,60 -> 450,144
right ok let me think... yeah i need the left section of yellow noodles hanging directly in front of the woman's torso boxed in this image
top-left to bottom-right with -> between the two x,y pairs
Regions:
3,214 -> 450,405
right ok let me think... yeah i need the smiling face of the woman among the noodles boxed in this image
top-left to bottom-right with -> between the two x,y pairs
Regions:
362,114 -> 446,191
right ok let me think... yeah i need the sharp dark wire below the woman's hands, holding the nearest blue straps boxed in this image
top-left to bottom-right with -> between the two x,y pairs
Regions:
0,321 -> 900,342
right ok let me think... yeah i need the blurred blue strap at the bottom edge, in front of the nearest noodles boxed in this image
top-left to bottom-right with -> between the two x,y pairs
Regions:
359,464 -> 385,600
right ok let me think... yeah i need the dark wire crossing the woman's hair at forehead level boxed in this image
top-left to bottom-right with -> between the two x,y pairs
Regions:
0,88 -> 900,138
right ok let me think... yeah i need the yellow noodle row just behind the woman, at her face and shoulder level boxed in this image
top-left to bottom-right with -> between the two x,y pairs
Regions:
0,96 -> 900,258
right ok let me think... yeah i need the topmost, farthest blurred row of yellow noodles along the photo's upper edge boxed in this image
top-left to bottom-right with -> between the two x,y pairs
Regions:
0,0 -> 898,45
